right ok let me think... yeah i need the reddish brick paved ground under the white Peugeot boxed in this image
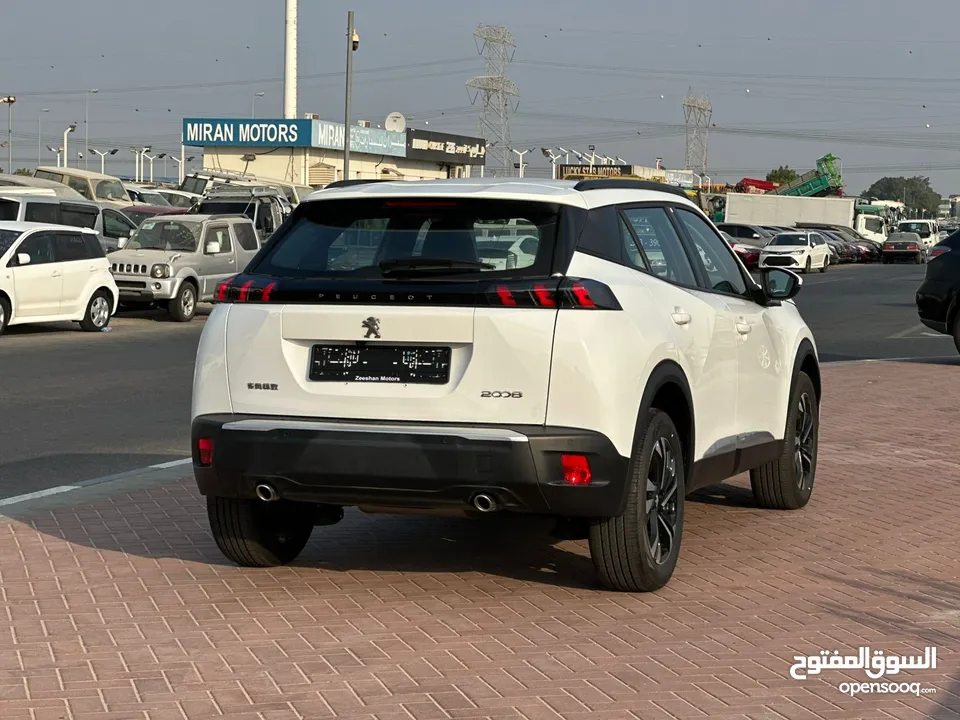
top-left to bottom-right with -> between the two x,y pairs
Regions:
0,364 -> 960,720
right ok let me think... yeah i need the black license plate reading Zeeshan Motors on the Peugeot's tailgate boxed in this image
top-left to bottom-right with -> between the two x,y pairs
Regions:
309,343 -> 450,385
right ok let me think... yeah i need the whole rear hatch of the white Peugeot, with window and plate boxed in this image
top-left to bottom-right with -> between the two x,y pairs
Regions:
218,198 -> 599,424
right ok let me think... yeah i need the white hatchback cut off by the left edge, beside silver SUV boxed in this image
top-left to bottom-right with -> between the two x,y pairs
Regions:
0,222 -> 119,333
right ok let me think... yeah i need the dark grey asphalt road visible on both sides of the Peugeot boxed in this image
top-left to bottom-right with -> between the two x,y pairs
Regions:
0,265 -> 960,500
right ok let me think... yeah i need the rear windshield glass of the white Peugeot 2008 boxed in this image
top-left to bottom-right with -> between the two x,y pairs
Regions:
251,198 -> 560,278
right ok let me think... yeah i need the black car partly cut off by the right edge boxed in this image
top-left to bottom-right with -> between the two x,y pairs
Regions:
916,233 -> 960,352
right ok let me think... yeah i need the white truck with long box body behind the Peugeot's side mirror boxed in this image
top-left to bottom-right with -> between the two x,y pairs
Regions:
714,193 -> 888,243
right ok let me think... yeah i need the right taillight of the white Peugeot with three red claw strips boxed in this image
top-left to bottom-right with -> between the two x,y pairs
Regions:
484,278 -> 623,310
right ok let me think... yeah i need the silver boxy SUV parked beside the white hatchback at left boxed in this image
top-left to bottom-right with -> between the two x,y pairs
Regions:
109,214 -> 260,322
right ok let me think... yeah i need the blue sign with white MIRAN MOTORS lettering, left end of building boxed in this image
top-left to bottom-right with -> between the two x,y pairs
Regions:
183,118 -> 314,147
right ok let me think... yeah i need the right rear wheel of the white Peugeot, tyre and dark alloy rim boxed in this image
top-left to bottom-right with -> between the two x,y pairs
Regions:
590,410 -> 686,592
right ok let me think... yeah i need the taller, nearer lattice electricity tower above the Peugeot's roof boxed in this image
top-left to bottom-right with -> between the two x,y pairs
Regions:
467,25 -> 520,176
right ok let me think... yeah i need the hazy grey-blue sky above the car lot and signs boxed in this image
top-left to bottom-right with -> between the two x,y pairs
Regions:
0,0 -> 960,195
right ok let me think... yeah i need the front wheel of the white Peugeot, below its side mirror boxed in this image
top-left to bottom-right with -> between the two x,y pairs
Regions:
750,372 -> 820,510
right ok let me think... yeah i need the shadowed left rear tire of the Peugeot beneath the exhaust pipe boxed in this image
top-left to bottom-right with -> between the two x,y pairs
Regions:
207,497 -> 313,567
